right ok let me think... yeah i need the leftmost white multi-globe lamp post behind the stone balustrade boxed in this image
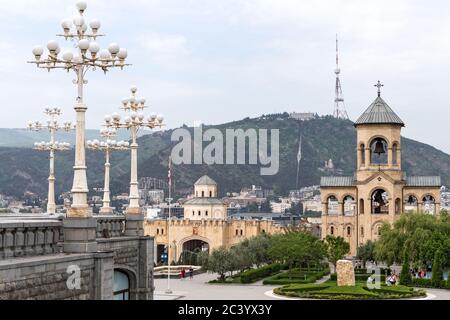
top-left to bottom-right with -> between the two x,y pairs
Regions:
28,108 -> 74,214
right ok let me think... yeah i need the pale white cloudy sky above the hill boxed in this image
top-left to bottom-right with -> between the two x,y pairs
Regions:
0,0 -> 450,153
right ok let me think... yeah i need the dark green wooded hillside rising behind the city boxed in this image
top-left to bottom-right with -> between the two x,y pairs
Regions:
0,114 -> 450,196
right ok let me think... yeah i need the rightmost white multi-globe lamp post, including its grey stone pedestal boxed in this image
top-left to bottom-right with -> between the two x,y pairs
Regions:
105,86 -> 164,235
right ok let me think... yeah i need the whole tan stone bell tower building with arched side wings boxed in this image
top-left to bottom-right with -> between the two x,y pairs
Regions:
320,82 -> 441,256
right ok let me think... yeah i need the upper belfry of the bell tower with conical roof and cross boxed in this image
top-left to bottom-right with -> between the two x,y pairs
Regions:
355,81 -> 405,181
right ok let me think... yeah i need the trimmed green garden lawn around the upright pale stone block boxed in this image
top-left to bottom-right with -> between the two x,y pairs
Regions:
274,281 -> 425,300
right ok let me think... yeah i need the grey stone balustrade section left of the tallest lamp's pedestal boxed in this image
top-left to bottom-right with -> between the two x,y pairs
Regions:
0,217 -> 62,260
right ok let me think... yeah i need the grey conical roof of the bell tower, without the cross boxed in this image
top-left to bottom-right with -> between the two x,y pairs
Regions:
355,97 -> 405,127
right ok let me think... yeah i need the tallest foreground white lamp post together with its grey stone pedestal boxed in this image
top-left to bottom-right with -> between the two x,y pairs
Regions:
31,1 -> 128,252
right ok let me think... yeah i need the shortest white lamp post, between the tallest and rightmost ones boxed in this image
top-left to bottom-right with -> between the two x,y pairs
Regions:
87,128 -> 129,214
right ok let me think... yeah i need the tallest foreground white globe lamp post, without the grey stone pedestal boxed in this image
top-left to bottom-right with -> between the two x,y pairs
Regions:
30,1 -> 128,217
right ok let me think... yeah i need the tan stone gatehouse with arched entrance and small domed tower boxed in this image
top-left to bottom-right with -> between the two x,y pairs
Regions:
144,176 -> 283,263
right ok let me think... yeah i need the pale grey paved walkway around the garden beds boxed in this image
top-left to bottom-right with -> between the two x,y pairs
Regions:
155,273 -> 450,300
